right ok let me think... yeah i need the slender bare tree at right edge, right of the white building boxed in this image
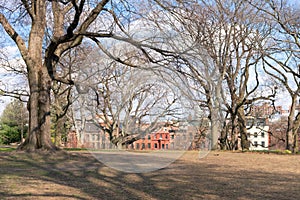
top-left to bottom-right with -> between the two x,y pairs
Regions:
250,0 -> 300,152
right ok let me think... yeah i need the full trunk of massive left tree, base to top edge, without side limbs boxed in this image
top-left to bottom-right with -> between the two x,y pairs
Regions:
19,1 -> 57,151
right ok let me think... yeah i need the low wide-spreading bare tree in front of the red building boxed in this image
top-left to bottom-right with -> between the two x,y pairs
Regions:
72,47 -> 182,148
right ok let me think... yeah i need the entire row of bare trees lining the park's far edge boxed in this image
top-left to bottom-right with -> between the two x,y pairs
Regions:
0,0 -> 300,152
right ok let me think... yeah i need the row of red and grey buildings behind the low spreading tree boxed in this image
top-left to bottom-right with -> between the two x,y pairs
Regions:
66,120 -> 209,150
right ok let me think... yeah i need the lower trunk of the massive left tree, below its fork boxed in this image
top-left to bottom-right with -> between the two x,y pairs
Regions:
19,67 -> 57,151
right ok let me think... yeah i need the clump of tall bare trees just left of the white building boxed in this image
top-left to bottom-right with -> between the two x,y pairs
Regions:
153,0 -> 275,149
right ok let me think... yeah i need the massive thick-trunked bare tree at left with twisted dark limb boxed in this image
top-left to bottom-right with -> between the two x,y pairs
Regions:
0,0 -> 139,151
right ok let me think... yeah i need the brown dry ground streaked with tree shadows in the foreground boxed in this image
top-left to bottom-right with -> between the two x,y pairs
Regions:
0,152 -> 300,200
